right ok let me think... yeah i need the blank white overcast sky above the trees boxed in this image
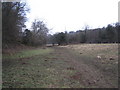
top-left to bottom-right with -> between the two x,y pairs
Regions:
26,0 -> 119,34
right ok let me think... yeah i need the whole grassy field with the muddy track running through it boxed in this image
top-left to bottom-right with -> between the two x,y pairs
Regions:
2,44 -> 118,88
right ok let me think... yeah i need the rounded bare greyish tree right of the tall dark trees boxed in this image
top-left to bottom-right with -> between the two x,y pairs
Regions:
32,19 -> 49,45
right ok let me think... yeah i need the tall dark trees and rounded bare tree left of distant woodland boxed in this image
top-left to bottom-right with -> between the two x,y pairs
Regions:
2,2 -> 49,48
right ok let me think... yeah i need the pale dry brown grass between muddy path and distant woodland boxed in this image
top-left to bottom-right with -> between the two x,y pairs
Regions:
66,44 -> 118,64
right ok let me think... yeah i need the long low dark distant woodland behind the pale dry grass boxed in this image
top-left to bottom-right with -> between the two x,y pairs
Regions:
48,23 -> 120,45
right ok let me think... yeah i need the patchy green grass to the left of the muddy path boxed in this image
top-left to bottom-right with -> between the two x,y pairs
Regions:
2,48 -> 83,88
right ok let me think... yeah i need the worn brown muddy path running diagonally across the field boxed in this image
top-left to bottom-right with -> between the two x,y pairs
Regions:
53,47 -> 117,88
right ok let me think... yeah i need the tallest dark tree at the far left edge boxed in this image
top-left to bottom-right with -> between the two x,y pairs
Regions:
2,2 -> 28,46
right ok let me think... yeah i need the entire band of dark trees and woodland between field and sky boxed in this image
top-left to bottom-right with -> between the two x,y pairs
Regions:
2,2 -> 120,48
